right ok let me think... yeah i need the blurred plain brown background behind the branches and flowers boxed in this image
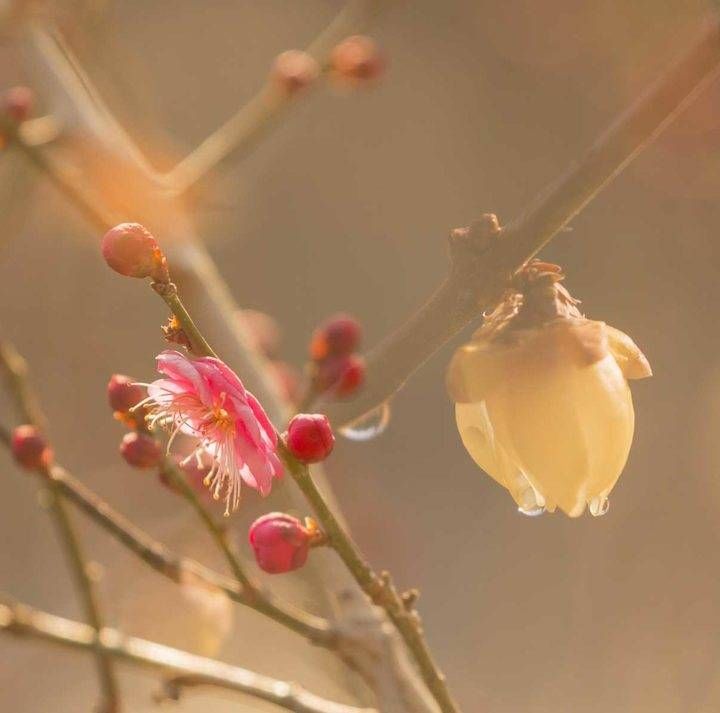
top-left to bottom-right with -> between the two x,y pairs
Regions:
0,0 -> 720,713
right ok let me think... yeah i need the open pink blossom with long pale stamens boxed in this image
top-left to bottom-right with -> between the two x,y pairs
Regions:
138,351 -> 282,514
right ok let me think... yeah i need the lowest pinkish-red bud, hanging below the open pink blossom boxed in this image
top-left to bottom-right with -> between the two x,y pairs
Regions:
248,512 -> 314,574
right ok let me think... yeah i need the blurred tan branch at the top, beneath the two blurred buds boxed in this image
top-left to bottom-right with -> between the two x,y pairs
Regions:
165,0 -> 380,194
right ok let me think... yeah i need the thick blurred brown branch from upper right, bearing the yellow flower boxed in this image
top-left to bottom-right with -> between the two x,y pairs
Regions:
320,17 -> 720,424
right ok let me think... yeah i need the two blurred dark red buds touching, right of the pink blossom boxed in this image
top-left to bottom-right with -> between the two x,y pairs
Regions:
310,314 -> 365,398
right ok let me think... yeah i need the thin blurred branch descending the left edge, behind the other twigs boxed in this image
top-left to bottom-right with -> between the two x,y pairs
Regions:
0,342 -> 120,713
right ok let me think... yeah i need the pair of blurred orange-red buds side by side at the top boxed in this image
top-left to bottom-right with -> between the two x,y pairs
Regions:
270,35 -> 386,95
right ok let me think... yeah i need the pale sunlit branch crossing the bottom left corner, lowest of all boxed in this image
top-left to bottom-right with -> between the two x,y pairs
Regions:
0,597 -> 377,713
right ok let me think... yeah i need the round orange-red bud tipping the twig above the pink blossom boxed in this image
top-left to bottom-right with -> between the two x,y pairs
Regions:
102,223 -> 170,282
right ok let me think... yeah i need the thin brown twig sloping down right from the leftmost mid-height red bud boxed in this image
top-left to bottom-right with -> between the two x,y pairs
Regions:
44,465 -> 335,648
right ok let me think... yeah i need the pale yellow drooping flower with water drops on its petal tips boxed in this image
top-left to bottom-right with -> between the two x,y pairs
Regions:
448,261 -> 652,517
